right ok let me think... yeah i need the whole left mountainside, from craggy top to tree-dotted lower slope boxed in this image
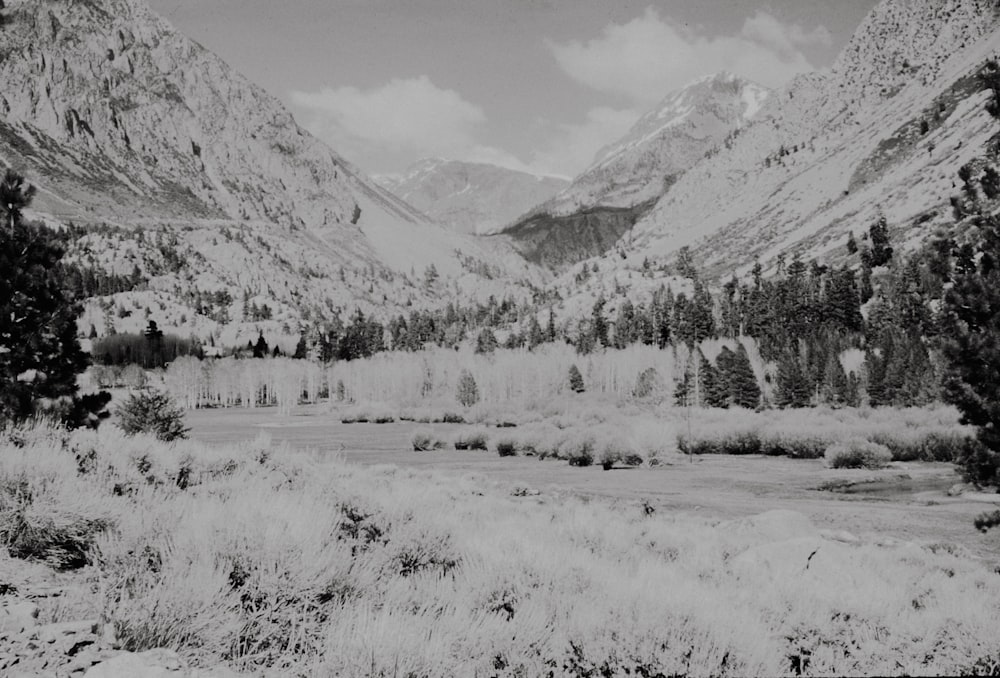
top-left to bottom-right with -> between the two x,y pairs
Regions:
0,0 -> 526,346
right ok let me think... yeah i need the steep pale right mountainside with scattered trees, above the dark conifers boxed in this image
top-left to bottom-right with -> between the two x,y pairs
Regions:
607,0 -> 1000,275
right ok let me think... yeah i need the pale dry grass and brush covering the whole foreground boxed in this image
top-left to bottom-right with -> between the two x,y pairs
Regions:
0,427 -> 1000,677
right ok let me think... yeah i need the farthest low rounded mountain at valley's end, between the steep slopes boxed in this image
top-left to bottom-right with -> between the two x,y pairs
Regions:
374,158 -> 569,234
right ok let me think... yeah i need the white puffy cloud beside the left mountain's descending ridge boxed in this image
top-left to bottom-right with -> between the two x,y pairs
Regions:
291,75 -> 486,173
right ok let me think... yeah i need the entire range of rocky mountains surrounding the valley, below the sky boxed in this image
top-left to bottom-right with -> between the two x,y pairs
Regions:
0,0 -> 1000,341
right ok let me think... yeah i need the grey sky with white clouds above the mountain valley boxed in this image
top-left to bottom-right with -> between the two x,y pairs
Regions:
146,0 -> 875,176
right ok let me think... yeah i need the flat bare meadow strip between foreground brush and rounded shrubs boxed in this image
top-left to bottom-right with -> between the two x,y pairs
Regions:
187,407 -> 1000,565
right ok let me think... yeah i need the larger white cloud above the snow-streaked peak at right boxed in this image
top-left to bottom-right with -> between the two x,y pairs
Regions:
549,8 -> 830,105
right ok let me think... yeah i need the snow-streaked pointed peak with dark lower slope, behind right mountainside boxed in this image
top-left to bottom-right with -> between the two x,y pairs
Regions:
504,73 -> 769,268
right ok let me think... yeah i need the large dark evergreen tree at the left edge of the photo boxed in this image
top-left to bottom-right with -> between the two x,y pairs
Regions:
0,171 -> 110,426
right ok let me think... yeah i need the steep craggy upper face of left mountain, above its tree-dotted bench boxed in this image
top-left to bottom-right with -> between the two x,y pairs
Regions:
0,0 -> 417,228
